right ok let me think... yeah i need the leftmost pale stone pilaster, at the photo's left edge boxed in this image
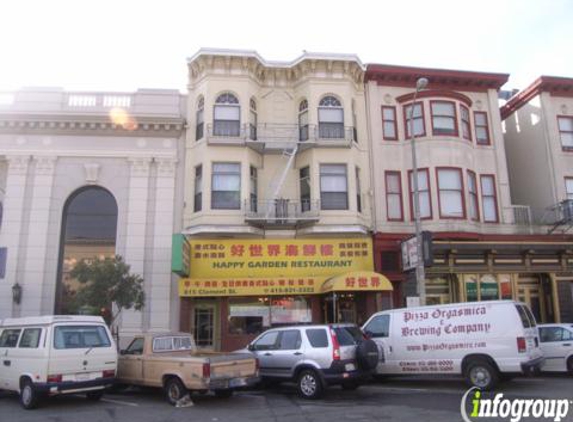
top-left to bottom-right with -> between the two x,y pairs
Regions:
0,155 -> 30,319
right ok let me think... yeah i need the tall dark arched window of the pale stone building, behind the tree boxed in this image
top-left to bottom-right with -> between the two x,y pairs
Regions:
55,186 -> 117,315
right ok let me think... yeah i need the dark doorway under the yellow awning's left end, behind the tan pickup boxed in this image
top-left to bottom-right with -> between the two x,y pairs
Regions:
192,302 -> 221,350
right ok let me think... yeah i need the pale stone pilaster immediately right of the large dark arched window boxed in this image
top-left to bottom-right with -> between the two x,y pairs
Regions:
120,157 -> 151,336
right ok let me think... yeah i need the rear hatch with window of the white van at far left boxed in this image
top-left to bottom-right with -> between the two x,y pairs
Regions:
48,323 -> 117,382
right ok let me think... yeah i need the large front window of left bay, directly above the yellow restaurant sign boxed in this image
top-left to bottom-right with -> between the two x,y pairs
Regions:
211,163 -> 241,210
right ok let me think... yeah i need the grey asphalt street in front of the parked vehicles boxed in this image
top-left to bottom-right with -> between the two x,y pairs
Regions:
0,376 -> 573,422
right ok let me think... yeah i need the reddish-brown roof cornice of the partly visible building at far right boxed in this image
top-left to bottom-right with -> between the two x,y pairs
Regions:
500,76 -> 573,120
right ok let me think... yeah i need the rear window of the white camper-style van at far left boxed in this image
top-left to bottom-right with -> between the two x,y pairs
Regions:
54,325 -> 111,349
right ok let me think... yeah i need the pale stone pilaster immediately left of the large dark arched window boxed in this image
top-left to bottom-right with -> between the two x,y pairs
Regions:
20,157 -> 56,316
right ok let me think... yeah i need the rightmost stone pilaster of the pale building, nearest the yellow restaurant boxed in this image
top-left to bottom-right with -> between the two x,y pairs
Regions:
146,157 -> 177,331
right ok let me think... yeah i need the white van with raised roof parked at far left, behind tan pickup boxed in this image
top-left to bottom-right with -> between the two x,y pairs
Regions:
0,316 -> 117,409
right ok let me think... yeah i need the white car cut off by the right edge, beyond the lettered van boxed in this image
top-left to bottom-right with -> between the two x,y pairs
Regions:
537,324 -> 573,375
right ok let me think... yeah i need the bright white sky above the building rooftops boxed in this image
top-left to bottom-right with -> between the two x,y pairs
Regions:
0,0 -> 573,92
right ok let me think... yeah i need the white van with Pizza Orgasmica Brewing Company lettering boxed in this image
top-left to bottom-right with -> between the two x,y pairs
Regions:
363,300 -> 544,390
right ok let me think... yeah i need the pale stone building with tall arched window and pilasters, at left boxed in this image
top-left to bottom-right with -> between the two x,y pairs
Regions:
0,88 -> 186,334
